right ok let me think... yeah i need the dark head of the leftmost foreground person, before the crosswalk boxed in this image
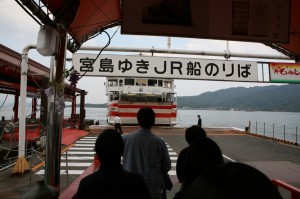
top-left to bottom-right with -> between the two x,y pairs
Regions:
95,129 -> 124,165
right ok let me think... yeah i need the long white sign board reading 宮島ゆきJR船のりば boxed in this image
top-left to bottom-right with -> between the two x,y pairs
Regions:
73,53 -> 258,82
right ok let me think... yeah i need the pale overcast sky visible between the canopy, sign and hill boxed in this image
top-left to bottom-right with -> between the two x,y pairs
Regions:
0,0 -> 292,103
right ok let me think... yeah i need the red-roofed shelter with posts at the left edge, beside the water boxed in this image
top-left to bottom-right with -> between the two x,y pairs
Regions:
0,44 -> 87,124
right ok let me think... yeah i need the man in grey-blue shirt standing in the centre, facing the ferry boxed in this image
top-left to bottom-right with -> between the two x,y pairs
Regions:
123,107 -> 171,199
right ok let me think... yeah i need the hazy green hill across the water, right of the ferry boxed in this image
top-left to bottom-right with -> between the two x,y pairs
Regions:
177,84 -> 300,112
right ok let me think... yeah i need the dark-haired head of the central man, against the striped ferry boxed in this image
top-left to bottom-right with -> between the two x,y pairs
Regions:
137,107 -> 155,129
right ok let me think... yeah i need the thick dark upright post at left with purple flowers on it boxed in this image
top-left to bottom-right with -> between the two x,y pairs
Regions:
45,29 -> 67,191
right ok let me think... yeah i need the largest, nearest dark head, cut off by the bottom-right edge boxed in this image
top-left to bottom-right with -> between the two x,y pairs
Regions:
186,162 -> 282,199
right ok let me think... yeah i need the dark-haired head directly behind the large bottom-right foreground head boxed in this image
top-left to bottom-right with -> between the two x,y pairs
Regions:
184,137 -> 224,186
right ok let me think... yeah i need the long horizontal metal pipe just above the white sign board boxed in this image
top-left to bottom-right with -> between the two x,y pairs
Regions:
79,46 -> 291,60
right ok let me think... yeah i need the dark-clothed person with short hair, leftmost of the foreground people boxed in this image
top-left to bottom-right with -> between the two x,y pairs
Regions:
76,129 -> 150,199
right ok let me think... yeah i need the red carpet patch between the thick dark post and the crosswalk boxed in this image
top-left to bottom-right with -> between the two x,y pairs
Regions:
61,128 -> 89,145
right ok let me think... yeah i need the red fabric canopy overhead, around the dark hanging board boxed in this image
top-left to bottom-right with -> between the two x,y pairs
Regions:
17,0 -> 300,62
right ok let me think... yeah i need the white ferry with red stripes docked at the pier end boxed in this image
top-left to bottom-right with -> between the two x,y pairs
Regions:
105,77 -> 177,126
